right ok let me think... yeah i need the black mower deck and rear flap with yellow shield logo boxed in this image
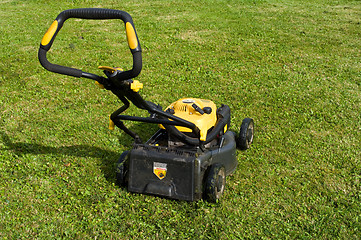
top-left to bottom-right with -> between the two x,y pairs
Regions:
127,131 -> 237,201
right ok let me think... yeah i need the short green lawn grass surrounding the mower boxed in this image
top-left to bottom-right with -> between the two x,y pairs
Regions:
0,0 -> 361,239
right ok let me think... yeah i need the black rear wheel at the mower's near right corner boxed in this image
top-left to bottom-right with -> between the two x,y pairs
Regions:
204,164 -> 226,202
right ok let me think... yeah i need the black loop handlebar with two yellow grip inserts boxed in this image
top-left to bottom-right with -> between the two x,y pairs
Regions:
38,8 -> 142,80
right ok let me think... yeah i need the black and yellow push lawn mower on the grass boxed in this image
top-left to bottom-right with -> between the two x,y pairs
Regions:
38,8 -> 254,202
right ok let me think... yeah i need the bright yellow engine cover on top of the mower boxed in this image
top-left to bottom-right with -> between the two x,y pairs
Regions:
160,98 -> 217,141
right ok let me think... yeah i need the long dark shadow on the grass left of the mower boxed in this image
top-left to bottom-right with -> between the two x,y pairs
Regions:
0,132 -> 121,182
